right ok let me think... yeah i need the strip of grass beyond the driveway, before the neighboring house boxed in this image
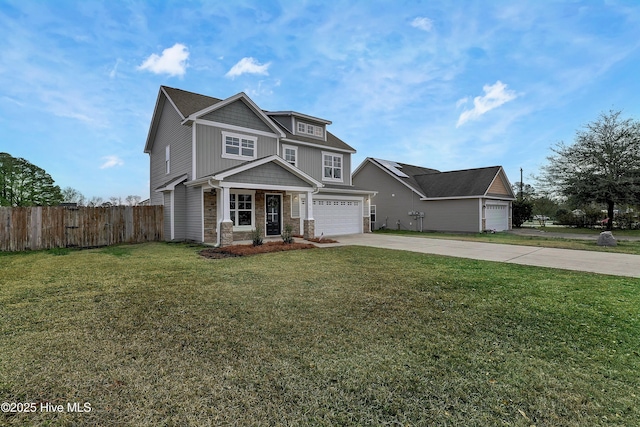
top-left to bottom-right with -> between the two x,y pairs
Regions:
375,227 -> 640,255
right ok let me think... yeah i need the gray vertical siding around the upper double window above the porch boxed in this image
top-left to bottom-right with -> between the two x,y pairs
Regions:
196,124 -> 278,178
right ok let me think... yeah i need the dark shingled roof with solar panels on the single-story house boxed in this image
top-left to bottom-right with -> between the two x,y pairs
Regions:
354,157 -> 515,200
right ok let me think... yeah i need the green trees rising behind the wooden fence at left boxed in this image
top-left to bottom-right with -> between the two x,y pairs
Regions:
0,153 -> 142,207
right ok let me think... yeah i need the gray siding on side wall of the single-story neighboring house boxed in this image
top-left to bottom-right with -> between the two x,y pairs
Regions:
353,162 -> 481,232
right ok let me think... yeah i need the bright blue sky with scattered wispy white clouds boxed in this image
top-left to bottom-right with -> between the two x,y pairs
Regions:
0,0 -> 640,199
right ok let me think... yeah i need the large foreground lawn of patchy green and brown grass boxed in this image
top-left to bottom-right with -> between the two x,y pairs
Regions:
0,243 -> 640,427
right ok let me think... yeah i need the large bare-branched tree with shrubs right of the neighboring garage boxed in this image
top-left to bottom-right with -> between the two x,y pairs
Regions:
512,110 -> 640,230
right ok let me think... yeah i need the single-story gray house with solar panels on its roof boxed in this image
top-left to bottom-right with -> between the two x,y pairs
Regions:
352,158 -> 515,233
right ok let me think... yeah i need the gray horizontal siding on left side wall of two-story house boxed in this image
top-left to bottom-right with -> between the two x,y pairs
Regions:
149,102 -> 191,205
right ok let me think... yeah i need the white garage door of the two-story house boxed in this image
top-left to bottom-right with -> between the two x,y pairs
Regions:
313,199 -> 362,236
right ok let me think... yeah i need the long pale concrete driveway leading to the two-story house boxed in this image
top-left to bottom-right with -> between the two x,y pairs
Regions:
322,234 -> 640,278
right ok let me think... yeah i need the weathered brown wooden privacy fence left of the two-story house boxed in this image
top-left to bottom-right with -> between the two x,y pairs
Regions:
0,206 -> 164,251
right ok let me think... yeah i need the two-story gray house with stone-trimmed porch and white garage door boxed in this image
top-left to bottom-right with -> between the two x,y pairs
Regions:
144,86 -> 375,245
